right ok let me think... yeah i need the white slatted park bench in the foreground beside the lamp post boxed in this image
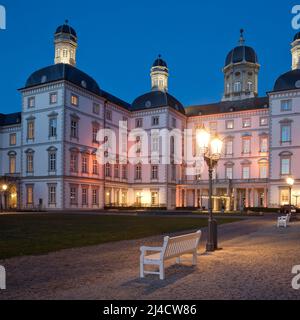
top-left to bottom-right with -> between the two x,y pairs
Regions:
140,230 -> 201,280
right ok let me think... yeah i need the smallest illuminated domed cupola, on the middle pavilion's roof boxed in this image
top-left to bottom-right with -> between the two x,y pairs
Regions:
150,55 -> 169,92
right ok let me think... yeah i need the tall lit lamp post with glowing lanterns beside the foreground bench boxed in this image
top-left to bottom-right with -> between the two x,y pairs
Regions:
196,127 -> 223,252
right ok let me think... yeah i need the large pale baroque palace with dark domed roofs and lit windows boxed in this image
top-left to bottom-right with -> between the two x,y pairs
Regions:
0,22 -> 300,210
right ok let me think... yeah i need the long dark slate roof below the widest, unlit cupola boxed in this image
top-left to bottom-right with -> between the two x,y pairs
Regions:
185,97 -> 269,117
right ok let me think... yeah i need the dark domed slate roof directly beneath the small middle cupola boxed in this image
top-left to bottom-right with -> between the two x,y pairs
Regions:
130,90 -> 185,114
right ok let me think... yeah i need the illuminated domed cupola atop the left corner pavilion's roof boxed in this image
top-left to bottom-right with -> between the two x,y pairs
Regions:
54,20 -> 77,66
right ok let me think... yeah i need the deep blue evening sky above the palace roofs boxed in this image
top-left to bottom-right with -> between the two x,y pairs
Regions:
0,0 -> 297,113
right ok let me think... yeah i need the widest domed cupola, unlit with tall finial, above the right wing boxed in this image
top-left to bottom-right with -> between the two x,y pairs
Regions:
223,29 -> 260,101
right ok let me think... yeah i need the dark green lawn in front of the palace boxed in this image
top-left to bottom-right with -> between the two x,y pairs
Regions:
0,214 -> 239,259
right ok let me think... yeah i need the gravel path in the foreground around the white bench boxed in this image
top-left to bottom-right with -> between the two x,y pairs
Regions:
0,218 -> 300,300
